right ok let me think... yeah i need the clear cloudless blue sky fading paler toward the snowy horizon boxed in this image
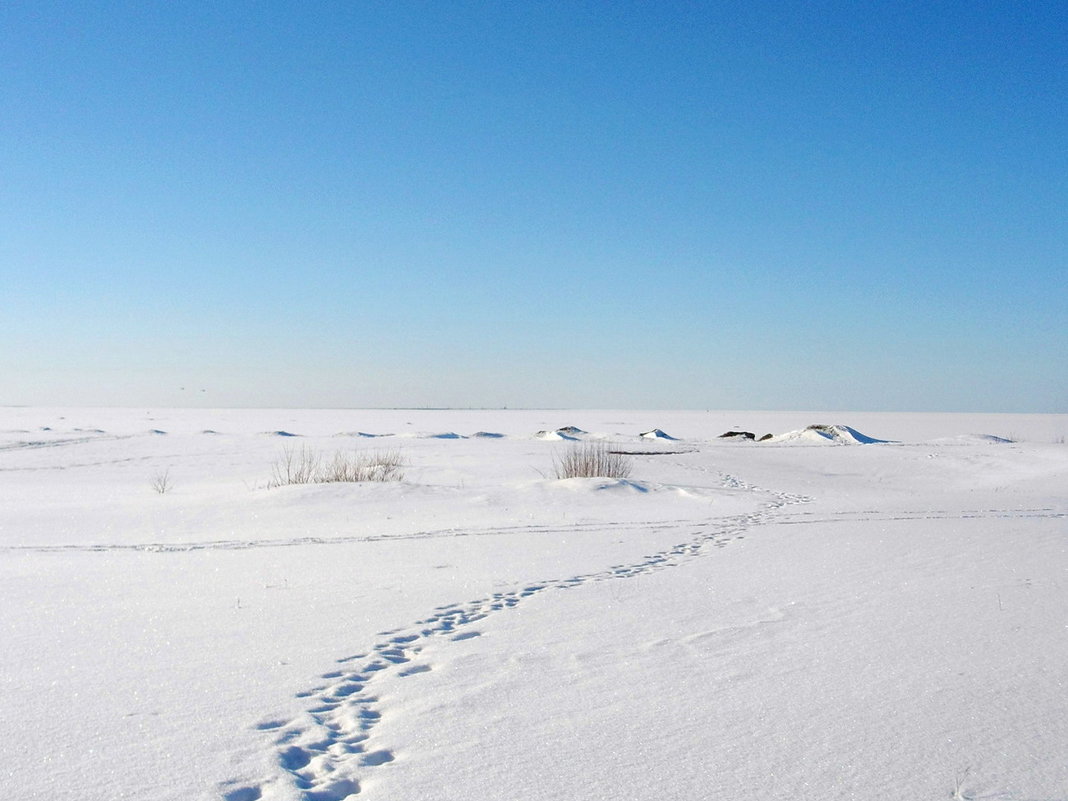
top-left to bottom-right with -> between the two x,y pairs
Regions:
0,0 -> 1068,412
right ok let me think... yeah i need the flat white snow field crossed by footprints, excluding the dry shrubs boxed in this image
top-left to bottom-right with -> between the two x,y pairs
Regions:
0,408 -> 1068,801
